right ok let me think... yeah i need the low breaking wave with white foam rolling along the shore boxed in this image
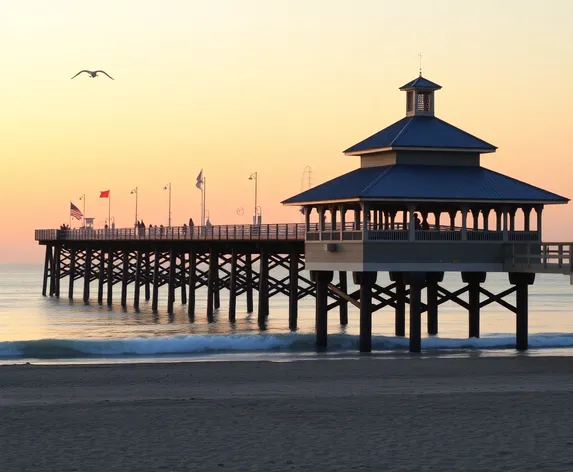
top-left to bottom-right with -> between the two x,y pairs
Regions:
0,333 -> 573,359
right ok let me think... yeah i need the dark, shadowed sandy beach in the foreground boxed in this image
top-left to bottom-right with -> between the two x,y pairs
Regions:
0,357 -> 573,471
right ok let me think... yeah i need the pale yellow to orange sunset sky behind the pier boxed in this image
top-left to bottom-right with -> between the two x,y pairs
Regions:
0,0 -> 573,263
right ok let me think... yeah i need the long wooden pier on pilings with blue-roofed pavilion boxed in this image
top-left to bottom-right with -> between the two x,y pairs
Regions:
35,76 -> 573,352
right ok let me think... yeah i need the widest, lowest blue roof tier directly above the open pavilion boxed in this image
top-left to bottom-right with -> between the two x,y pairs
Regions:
282,164 -> 569,204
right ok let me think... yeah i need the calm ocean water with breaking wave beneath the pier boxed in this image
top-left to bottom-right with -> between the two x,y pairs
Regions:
0,265 -> 573,364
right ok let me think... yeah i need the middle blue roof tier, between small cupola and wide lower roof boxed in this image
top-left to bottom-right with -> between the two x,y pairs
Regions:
344,116 -> 497,154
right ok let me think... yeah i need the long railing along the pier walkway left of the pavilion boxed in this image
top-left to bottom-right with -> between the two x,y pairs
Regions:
35,223 -> 305,241
